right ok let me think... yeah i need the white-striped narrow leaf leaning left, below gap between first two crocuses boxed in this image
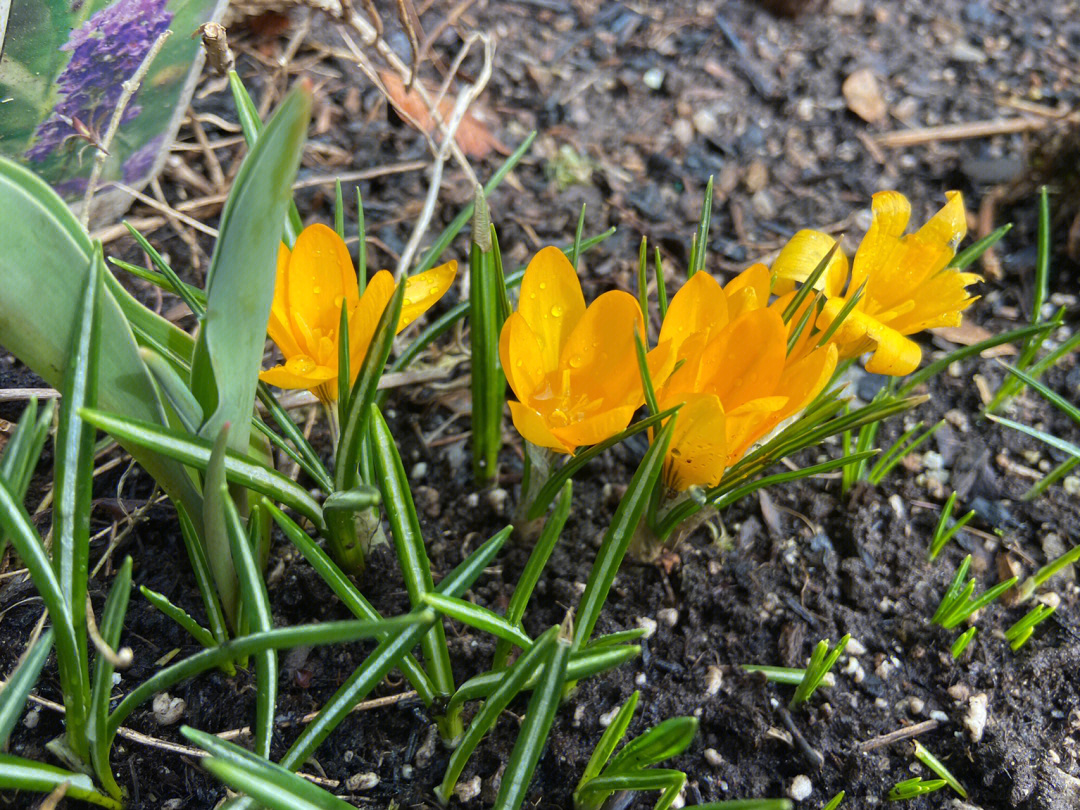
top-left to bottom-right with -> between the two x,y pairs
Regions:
372,407 -> 456,704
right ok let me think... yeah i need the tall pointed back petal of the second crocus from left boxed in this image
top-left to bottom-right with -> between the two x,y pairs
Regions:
517,247 -> 585,373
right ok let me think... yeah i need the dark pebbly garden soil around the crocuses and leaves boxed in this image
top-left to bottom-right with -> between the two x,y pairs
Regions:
0,0 -> 1080,810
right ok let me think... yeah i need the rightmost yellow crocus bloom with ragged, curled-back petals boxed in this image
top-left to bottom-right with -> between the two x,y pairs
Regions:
772,191 -> 980,377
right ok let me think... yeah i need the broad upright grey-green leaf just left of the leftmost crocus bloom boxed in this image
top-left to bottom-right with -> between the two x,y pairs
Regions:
191,84 -> 311,460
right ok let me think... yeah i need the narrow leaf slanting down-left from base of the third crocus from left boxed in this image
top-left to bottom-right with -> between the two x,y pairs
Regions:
573,415 -> 678,650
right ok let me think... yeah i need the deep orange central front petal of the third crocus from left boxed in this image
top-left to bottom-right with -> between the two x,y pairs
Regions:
700,309 -> 787,414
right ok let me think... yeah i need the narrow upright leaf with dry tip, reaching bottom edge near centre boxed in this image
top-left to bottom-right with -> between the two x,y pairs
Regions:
494,634 -> 572,810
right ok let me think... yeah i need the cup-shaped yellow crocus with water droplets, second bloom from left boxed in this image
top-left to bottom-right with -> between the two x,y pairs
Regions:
499,247 -> 669,454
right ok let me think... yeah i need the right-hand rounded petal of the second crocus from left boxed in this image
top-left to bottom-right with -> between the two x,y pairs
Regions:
558,289 -> 645,406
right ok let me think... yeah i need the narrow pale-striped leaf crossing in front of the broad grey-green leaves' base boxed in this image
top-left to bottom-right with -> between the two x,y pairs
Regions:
80,409 -> 326,531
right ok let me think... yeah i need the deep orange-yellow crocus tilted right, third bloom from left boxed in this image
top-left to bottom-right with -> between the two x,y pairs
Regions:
657,270 -> 837,491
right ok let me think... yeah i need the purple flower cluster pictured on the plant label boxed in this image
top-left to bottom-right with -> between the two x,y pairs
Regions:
26,0 -> 173,163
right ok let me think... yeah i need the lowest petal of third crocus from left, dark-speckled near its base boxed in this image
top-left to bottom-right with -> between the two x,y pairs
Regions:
664,394 -> 728,491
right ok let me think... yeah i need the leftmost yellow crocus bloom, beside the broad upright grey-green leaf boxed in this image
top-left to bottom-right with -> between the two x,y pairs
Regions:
259,225 -> 458,404
